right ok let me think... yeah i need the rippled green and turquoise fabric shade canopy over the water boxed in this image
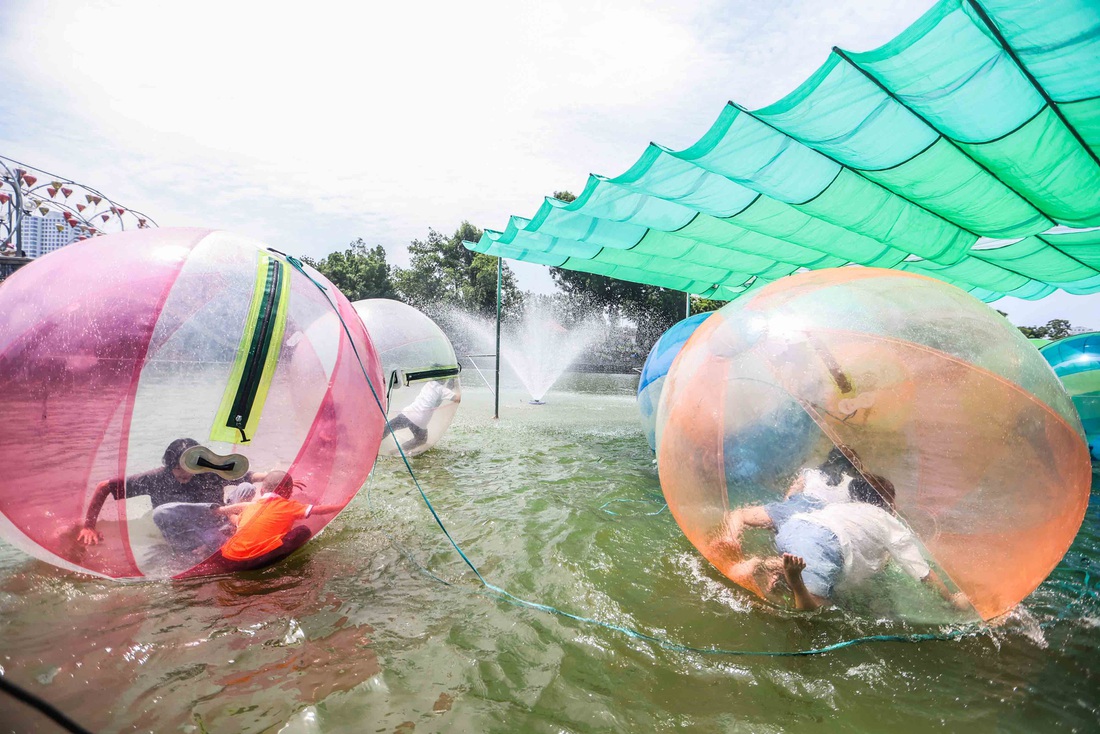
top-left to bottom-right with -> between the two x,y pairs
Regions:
465,0 -> 1100,302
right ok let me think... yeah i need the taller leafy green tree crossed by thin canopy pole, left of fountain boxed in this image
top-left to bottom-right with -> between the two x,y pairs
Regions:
394,221 -> 523,315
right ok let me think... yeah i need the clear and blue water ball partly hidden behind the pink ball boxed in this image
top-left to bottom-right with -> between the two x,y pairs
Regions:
352,298 -> 462,457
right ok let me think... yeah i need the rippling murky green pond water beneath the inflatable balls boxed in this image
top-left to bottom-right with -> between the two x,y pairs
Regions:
0,375 -> 1100,732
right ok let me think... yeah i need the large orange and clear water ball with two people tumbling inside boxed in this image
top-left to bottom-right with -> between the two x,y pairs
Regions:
657,267 -> 1091,621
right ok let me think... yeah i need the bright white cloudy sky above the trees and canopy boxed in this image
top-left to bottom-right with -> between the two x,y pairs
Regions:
0,0 -> 1100,327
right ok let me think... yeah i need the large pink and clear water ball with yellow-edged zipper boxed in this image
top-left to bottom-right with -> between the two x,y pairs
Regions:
0,229 -> 384,579
